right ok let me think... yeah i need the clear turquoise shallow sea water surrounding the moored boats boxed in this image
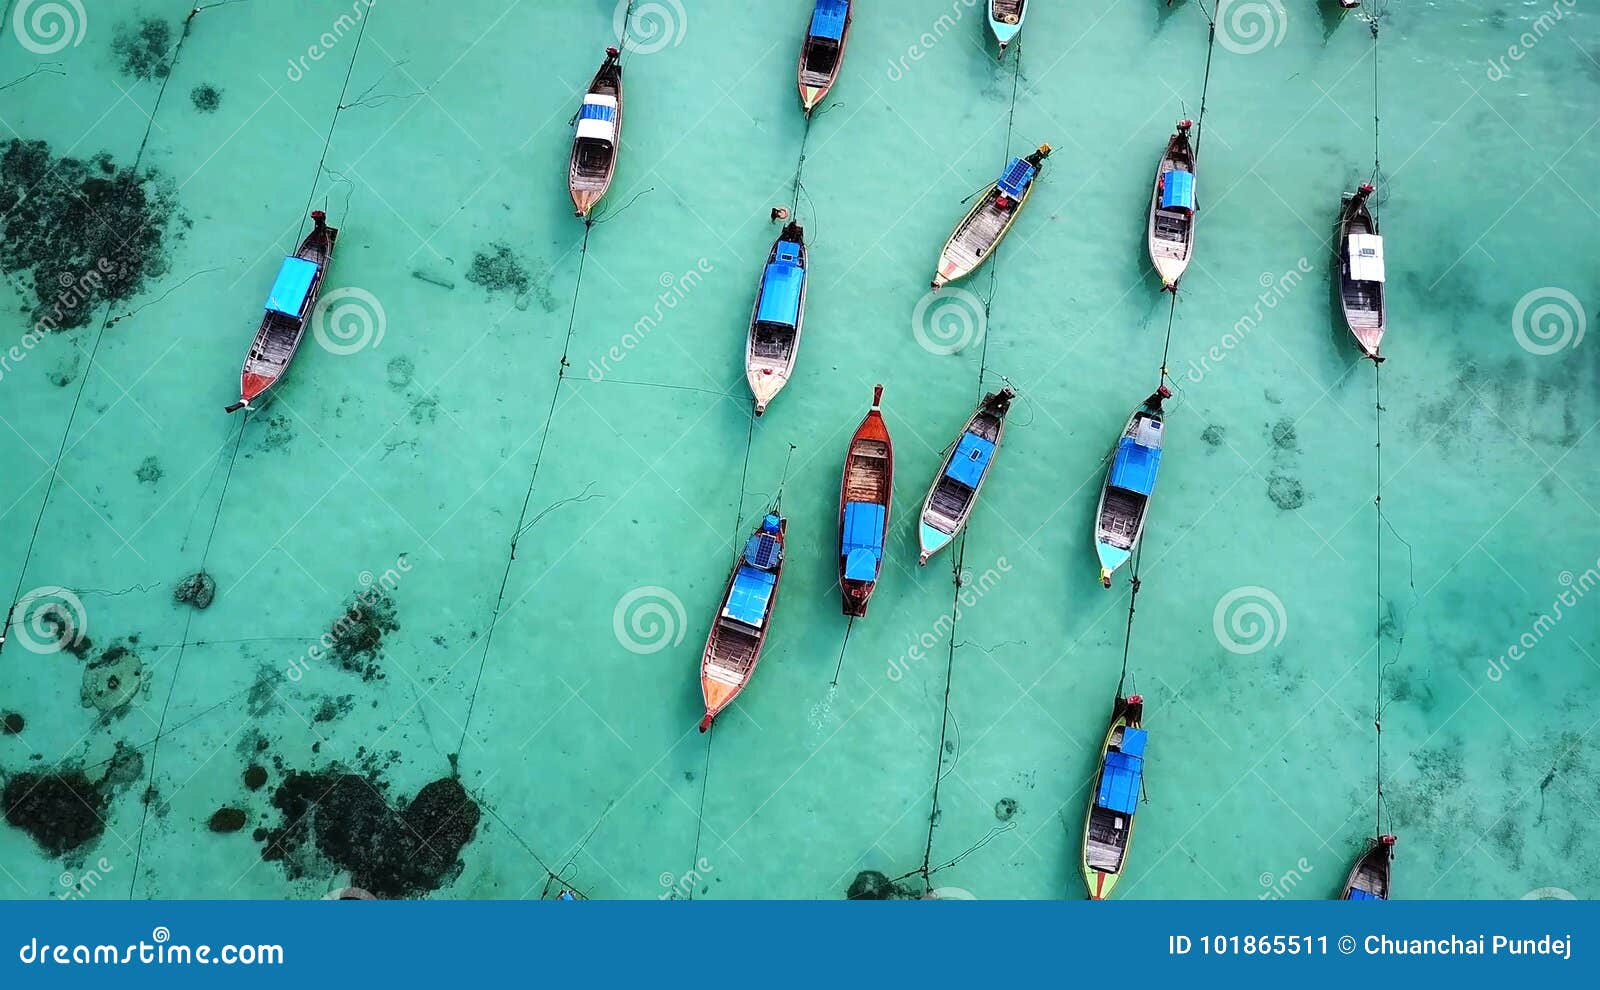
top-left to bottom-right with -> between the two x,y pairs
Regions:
0,0 -> 1600,899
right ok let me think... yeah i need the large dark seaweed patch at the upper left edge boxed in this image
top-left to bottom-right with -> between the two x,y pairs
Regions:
0,138 -> 178,332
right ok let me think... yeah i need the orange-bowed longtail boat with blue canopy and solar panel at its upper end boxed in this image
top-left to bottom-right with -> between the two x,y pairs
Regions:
701,505 -> 789,733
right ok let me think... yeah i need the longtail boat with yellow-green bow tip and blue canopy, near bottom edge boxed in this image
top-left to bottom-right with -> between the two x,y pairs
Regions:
1083,694 -> 1146,900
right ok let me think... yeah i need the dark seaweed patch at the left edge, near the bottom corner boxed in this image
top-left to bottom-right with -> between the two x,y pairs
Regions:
0,742 -> 144,860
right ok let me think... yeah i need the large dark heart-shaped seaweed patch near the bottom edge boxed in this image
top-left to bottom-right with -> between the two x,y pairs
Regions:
261,768 -> 482,897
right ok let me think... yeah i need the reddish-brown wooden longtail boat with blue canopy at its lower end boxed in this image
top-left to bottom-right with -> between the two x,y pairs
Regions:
838,385 -> 894,616
